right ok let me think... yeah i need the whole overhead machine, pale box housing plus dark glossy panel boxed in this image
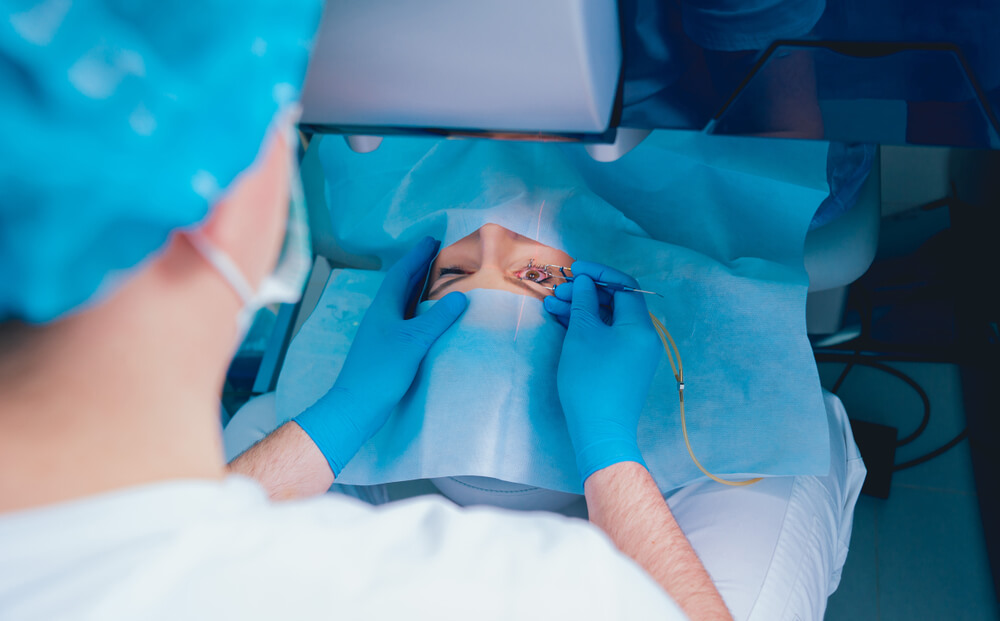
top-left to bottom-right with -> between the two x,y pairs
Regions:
304,0 -> 1000,153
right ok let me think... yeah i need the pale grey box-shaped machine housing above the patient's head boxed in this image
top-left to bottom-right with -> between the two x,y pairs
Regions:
302,0 -> 622,142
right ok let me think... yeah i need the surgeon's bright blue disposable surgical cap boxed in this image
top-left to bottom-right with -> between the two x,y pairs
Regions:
0,0 -> 321,322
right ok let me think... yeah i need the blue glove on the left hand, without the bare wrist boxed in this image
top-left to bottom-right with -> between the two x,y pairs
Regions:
294,237 -> 467,477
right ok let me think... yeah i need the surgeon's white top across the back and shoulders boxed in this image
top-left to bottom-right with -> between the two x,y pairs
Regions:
0,476 -> 685,620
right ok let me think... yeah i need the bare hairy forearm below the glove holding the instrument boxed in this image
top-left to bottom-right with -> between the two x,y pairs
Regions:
584,462 -> 732,619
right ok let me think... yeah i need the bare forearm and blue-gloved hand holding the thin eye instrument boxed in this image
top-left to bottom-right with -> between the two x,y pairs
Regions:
545,261 -> 731,619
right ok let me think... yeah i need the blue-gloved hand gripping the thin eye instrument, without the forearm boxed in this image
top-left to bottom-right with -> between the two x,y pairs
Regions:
544,261 -> 662,481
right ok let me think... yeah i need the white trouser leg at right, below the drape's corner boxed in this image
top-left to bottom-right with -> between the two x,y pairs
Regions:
667,393 -> 865,621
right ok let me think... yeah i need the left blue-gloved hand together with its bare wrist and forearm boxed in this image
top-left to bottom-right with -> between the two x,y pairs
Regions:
230,237 -> 466,498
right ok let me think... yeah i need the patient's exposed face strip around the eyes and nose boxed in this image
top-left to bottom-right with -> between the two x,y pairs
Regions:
425,224 -> 573,300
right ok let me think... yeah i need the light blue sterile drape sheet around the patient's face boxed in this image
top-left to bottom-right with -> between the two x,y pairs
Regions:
277,132 -> 829,493
